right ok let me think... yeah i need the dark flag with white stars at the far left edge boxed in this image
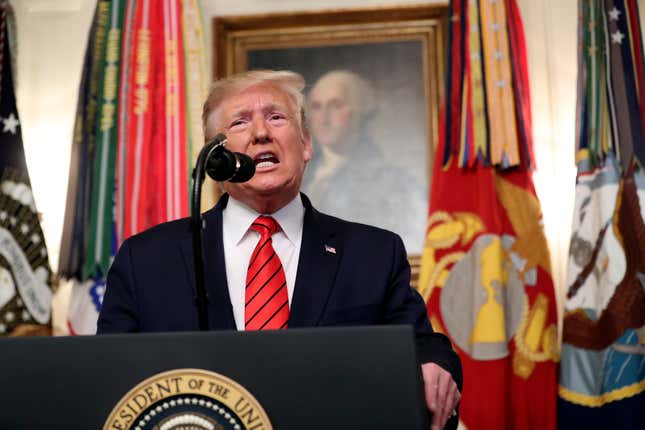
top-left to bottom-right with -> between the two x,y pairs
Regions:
0,1 -> 52,336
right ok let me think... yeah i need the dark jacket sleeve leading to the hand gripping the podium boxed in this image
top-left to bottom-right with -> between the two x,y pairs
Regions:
385,235 -> 462,391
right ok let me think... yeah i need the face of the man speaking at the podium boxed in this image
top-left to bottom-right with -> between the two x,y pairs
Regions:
209,84 -> 311,211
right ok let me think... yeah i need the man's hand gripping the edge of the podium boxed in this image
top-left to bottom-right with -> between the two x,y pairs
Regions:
421,363 -> 461,430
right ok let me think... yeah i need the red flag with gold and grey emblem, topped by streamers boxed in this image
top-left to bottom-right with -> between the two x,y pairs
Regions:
419,0 -> 559,429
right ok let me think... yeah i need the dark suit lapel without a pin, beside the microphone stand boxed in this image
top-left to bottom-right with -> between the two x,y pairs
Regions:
181,194 -> 236,330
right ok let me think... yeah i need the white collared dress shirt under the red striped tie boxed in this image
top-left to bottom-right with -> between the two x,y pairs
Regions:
222,195 -> 305,330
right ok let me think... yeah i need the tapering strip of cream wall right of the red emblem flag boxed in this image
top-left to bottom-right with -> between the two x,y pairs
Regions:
518,0 -> 578,320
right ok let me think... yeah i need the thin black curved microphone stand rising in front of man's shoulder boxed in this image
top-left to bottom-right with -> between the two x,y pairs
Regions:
190,135 -> 226,331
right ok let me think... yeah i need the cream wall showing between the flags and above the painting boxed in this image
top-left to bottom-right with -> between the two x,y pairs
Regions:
11,0 -> 588,331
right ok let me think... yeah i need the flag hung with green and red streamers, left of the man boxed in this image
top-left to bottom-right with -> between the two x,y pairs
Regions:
59,0 -> 206,334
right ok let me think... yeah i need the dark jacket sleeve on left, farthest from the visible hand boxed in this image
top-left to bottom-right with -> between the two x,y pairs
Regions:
96,240 -> 139,334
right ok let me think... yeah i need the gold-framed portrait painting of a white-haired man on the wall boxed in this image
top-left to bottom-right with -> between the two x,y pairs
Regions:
212,4 -> 448,284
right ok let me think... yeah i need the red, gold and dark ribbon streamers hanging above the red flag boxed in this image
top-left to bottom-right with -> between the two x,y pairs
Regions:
442,0 -> 534,170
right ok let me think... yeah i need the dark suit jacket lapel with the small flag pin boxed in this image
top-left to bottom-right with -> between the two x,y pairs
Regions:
289,194 -> 342,327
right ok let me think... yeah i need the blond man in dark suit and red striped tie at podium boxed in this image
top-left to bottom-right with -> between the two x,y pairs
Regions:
98,71 -> 461,429
